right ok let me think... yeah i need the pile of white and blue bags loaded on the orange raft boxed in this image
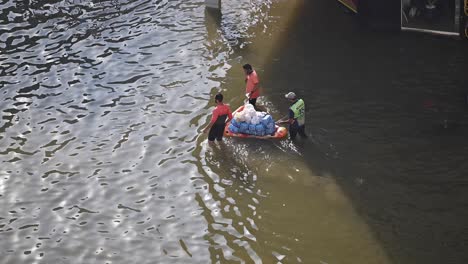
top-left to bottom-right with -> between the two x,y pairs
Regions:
229,104 -> 275,136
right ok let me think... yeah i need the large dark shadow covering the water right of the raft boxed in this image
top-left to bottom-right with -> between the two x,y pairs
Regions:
253,1 -> 468,263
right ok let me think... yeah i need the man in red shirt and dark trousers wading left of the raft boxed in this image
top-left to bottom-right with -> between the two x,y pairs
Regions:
203,93 -> 232,143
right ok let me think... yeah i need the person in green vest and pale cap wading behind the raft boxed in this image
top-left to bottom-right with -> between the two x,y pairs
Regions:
277,92 -> 307,140
